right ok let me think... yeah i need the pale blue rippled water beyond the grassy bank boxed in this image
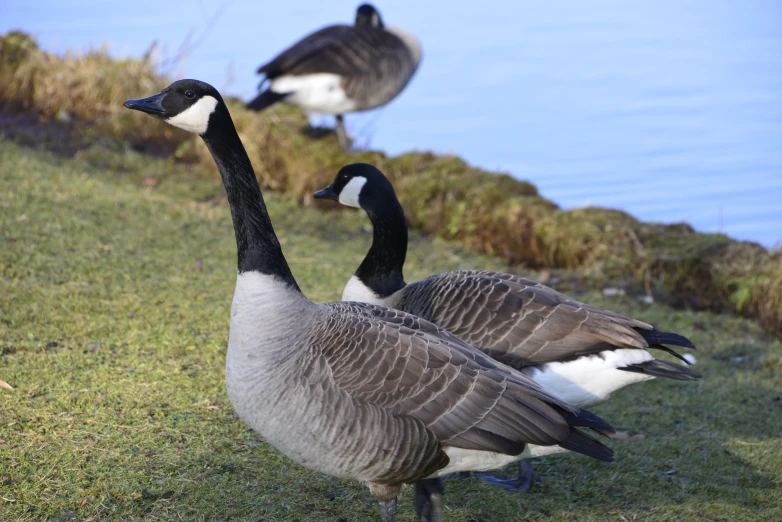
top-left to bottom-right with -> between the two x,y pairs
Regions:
0,0 -> 782,247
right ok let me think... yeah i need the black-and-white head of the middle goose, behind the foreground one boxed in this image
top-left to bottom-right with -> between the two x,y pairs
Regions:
313,163 -> 396,210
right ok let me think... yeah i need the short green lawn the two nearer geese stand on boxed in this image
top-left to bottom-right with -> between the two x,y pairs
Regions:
0,141 -> 782,522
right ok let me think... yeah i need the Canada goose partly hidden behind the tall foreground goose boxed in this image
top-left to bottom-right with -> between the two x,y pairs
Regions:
315,163 -> 701,491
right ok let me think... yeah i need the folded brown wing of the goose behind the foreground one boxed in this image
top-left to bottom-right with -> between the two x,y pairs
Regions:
396,270 -> 680,369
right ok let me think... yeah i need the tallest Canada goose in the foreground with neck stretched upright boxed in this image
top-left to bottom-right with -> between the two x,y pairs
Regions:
125,80 -> 613,521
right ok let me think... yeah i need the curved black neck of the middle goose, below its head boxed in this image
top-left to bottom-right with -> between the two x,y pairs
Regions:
356,195 -> 407,297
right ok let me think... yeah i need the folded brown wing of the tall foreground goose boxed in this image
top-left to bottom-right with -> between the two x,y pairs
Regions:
313,303 -> 578,460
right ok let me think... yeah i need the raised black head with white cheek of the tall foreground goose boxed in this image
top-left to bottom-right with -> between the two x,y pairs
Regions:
124,80 -> 225,136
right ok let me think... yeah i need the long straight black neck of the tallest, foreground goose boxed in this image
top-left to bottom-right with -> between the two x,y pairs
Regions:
203,106 -> 300,291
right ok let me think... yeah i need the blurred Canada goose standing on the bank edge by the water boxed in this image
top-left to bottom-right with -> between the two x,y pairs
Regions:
247,4 -> 421,149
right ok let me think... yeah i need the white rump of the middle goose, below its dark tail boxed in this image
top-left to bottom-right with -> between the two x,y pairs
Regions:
524,348 -> 654,408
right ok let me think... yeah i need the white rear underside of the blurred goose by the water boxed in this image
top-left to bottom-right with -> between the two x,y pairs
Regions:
270,73 -> 356,114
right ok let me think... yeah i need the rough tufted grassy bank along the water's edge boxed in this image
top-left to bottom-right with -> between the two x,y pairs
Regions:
0,33 -> 782,331
